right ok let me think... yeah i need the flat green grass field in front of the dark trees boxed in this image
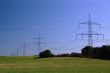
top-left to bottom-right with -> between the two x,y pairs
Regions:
0,57 -> 110,73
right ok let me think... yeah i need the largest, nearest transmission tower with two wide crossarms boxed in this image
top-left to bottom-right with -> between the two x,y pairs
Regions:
76,13 -> 104,46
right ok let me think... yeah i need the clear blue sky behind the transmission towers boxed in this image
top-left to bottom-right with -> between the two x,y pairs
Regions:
0,0 -> 110,55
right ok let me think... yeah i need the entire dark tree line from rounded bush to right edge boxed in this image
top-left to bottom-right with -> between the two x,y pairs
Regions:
39,45 -> 110,59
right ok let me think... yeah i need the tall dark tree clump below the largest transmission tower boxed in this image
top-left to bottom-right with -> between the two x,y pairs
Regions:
82,45 -> 110,59
